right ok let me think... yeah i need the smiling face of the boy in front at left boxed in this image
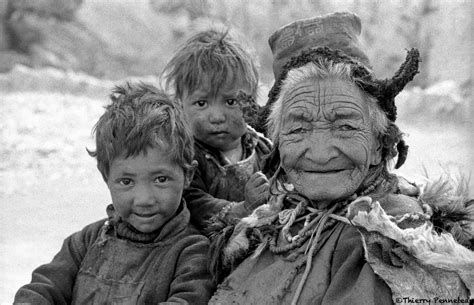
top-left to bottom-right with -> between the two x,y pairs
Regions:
107,145 -> 189,233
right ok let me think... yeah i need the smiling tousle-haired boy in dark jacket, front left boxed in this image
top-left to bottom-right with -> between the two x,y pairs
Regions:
15,84 -> 213,304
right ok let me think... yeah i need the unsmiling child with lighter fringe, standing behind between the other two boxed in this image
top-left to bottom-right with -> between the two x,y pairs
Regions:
163,29 -> 271,229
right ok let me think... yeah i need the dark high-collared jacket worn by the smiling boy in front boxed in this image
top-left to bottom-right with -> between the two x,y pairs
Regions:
15,203 -> 213,304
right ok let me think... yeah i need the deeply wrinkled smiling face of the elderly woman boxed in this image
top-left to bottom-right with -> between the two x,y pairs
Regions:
279,79 -> 381,204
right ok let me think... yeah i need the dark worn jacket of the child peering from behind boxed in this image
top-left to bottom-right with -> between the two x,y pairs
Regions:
184,127 -> 271,229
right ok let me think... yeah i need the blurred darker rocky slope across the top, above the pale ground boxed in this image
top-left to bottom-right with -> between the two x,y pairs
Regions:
0,0 -> 473,84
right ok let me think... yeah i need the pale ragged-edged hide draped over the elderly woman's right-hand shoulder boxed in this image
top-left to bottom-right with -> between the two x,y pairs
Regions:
349,194 -> 474,303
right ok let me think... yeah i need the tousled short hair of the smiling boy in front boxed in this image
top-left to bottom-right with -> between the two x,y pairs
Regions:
88,83 -> 194,181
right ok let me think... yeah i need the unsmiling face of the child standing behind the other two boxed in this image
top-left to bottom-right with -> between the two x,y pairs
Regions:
182,76 -> 250,151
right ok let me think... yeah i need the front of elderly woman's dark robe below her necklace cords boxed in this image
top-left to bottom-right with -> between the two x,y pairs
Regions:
210,223 -> 392,305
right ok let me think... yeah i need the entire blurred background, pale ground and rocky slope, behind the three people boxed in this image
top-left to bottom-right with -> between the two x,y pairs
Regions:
0,0 -> 474,304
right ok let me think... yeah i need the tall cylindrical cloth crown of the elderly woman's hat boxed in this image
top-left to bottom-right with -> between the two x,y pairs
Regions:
268,12 -> 370,80
